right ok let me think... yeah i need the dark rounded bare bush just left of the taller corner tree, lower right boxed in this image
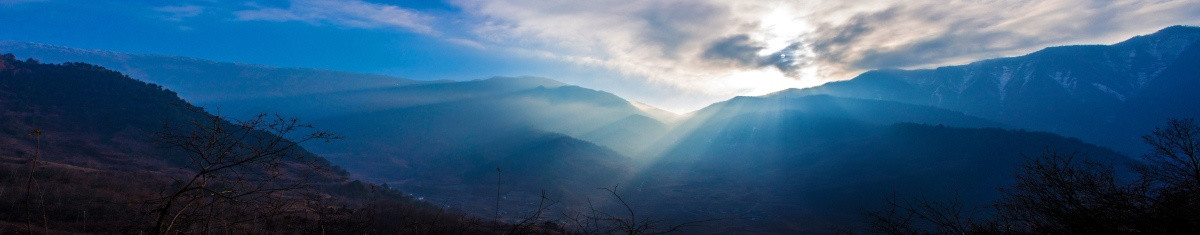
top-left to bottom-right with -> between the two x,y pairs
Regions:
997,150 -> 1151,234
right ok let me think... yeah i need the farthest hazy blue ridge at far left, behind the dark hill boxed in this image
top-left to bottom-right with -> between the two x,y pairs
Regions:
0,41 -> 419,107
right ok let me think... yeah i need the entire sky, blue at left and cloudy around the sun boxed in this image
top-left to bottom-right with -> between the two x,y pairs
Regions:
0,0 -> 1200,113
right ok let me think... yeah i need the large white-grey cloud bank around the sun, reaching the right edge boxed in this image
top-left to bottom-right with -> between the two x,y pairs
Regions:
454,0 -> 1200,96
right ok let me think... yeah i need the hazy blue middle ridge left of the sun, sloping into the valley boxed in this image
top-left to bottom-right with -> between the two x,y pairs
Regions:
201,77 -> 676,151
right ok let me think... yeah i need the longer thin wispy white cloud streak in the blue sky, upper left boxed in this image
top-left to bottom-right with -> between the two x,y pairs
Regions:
233,0 -> 438,35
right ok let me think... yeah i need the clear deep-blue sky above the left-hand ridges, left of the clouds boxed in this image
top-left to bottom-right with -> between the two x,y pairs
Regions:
0,1 -> 566,79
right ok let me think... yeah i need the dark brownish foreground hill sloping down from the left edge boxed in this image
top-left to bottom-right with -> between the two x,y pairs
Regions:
0,54 -> 511,234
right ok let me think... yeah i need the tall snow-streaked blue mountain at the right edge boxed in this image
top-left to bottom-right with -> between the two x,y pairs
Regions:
773,26 -> 1200,155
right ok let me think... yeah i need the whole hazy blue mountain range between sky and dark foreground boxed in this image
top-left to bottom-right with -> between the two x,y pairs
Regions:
0,26 -> 1200,233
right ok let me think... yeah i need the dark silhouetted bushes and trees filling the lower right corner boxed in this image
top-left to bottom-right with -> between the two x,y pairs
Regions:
868,119 -> 1200,234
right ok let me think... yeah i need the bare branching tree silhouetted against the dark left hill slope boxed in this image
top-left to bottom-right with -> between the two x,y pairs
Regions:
149,108 -> 338,234
